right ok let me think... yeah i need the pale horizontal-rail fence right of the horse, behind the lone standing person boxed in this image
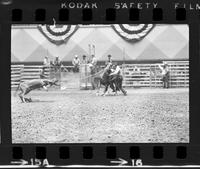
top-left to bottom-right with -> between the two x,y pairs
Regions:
122,61 -> 189,87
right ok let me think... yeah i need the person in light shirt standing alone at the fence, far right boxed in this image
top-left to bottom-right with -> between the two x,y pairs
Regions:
159,63 -> 169,88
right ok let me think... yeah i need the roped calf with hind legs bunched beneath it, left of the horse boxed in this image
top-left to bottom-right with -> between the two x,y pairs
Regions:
17,79 -> 58,103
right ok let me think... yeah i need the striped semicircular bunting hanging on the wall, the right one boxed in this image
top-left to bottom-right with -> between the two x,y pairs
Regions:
112,24 -> 154,42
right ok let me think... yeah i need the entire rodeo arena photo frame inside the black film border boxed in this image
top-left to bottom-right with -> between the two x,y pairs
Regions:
11,24 -> 189,143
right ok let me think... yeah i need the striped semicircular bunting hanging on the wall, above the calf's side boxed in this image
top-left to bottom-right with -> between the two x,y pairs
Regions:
38,25 -> 78,45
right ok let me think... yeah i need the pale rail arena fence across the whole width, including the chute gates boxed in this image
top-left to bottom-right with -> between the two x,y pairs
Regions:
11,61 -> 189,89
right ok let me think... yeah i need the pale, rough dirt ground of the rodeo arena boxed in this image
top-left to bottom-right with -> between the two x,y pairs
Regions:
11,89 -> 189,143
